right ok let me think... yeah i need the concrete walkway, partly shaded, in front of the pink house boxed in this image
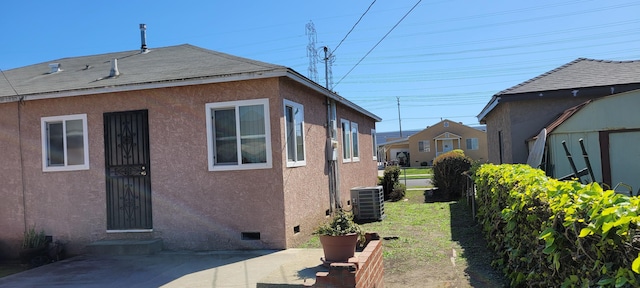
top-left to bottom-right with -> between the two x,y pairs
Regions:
0,249 -> 326,288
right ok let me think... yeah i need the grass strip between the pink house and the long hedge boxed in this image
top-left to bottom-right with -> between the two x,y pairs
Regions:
301,189 -> 503,287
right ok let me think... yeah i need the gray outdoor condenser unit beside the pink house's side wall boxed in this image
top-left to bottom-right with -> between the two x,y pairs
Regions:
351,186 -> 385,220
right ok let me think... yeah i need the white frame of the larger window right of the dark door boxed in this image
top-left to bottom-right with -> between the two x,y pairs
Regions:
205,98 -> 273,171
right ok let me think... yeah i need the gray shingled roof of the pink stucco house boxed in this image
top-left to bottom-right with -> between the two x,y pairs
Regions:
0,44 -> 287,97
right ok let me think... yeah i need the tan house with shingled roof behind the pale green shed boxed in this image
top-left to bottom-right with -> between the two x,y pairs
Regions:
478,58 -> 640,163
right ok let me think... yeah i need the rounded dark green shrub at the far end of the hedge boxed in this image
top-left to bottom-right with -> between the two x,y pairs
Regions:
432,150 -> 471,199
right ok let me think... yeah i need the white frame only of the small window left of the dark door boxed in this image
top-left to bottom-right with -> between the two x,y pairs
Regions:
40,114 -> 89,172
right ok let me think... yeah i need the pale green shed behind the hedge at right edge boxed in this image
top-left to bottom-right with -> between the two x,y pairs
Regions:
546,90 -> 640,194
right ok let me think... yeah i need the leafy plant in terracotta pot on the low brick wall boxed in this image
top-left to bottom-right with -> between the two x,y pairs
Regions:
314,210 -> 365,264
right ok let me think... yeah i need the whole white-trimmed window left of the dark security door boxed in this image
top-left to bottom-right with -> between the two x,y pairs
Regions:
40,114 -> 89,172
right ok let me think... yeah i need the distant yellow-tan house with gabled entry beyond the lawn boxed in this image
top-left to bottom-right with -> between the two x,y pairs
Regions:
380,119 -> 487,167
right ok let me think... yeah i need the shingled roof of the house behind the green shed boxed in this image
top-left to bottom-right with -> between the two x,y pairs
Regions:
496,58 -> 640,96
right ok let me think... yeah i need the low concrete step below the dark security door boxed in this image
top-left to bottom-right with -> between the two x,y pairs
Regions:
87,238 -> 162,255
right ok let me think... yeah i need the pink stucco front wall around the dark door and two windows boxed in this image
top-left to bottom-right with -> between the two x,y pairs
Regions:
3,79 -> 294,253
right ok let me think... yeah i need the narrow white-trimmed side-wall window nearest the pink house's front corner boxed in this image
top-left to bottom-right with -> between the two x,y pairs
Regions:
284,100 -> 307,167
